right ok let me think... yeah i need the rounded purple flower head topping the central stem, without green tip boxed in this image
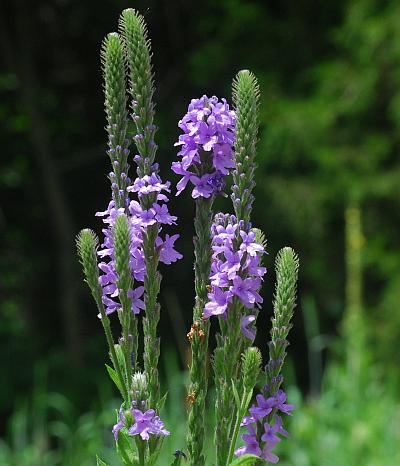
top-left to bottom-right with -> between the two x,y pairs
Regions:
172,95 -> 236,199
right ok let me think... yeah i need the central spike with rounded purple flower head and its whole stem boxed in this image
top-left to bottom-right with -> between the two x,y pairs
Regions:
172,95 -> 235,466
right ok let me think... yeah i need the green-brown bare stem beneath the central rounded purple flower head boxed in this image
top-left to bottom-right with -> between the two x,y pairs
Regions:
187,197 -> 213,466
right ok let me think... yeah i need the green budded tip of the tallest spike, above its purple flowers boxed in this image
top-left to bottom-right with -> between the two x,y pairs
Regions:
119,8 -> 157,176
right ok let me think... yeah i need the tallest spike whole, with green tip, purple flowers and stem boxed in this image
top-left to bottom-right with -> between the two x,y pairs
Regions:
119,9 -> 182,438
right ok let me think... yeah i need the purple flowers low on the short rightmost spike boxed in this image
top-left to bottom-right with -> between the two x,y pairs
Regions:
235,386 -> 294,463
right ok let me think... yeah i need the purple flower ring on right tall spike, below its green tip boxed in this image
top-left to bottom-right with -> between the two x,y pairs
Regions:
203,214 -> 266,339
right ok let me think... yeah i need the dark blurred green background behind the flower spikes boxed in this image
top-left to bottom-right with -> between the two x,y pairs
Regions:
0,0 -> 400,466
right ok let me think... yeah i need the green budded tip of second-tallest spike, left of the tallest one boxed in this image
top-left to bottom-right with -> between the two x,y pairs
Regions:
101,32 -> 129,208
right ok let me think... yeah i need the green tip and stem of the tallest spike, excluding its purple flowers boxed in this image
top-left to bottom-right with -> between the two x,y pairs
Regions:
120,9 -> 161,416
